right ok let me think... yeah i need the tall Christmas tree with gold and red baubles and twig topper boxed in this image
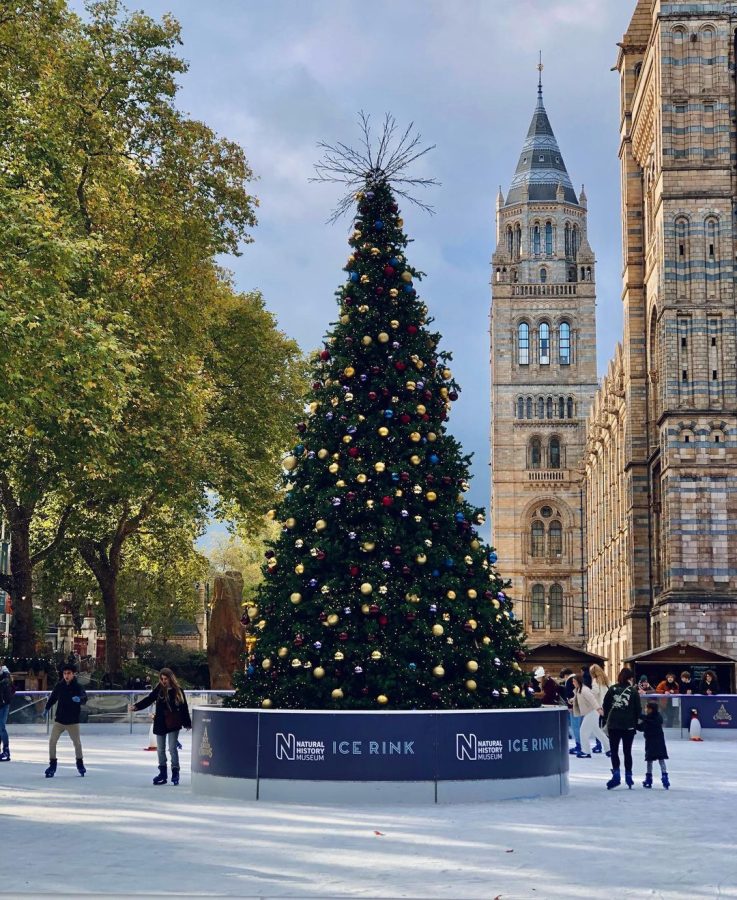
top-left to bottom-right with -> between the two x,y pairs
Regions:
231,120 -> 527,709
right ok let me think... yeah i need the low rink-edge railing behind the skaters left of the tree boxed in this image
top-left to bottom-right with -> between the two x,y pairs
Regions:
8,690 -> 234,734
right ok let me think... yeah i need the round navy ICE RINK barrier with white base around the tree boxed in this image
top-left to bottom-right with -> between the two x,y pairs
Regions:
192,707 -> 569,804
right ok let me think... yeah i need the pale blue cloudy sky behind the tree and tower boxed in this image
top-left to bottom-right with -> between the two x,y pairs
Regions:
70,0 -> 635,532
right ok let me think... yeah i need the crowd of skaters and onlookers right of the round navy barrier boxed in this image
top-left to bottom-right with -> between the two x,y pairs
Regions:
530,665 -> 719,790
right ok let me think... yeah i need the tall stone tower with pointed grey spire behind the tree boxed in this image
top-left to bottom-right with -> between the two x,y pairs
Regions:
491,72 -> 597,645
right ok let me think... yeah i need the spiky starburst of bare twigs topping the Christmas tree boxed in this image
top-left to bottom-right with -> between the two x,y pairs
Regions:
310,111 -> 440,222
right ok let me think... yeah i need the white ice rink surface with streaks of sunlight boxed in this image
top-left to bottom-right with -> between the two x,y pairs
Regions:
0,725 -> 737,900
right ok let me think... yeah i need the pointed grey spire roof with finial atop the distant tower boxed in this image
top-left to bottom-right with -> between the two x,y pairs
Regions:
506,66 -> 578,206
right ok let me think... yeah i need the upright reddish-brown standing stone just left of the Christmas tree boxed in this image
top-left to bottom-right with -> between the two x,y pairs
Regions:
207,572 -> 244,690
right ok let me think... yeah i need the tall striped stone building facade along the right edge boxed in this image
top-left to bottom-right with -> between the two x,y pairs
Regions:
583,0 -> 737,669
